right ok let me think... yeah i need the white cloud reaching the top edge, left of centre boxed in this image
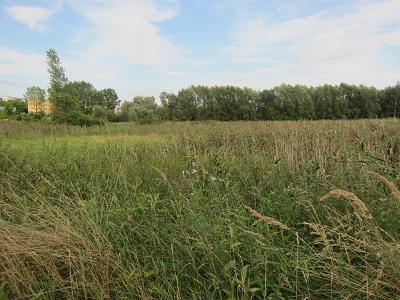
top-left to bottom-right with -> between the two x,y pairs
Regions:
73,0 -> 185,67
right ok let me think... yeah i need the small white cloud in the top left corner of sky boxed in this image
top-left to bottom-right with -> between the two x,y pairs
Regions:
6,5 -> 54,30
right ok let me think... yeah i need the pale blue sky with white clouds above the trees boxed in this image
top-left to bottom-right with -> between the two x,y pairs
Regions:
0,0 -> 400,100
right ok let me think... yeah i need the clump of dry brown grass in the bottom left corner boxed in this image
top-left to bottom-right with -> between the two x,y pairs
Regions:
0,209 -> 119,299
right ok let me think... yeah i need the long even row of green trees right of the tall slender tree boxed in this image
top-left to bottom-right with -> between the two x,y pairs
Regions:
122,83 -> 400,122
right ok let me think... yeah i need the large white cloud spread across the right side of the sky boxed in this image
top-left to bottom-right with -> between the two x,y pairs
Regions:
226,0 -> 400,87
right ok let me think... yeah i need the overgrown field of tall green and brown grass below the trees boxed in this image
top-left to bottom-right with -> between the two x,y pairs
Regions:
0,119 -> 400,299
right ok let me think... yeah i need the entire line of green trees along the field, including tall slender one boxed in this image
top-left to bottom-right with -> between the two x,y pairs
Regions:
1,49 -> 400,125
